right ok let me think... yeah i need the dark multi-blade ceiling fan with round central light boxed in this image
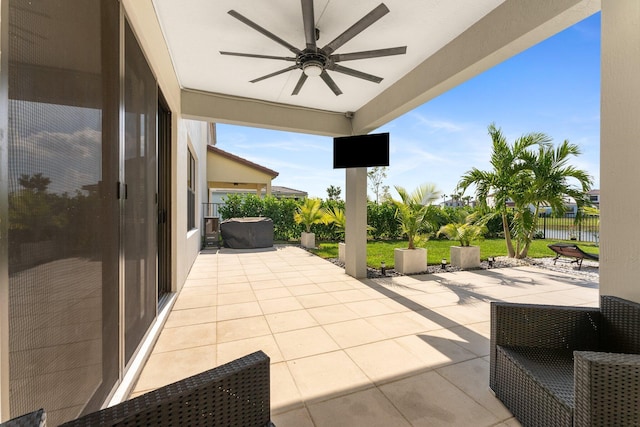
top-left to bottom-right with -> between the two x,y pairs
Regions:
220,0 -> 407,96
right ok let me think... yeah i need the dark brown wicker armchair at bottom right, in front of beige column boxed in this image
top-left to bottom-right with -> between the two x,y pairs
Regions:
489,296 -> 640,426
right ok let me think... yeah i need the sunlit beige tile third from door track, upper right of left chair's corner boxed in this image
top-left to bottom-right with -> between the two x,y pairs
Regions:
274,326 -> 339,360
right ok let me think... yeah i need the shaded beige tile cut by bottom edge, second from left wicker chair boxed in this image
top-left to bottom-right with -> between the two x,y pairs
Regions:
309,388 -> 410,427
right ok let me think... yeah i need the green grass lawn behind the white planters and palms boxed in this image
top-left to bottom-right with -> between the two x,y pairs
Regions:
311,239 -> 600,268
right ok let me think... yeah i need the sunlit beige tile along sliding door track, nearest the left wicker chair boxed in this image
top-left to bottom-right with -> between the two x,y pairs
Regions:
133,345 -> 217,393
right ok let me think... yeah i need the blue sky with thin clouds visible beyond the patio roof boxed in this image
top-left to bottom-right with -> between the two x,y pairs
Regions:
217,13 -> 600,199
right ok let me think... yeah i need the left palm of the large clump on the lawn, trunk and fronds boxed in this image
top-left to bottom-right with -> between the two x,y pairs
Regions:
458,123 -> 550,258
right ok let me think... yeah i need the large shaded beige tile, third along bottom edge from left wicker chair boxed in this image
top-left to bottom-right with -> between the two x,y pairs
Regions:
380,371 -> 500,427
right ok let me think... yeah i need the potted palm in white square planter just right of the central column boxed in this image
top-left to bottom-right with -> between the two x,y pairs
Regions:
392,183 -> 440,249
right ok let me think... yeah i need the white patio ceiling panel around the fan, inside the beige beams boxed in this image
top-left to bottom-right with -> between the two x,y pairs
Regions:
153,0 -> 504,112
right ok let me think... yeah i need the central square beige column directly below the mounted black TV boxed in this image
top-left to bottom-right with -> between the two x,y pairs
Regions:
344,168 -> 367,279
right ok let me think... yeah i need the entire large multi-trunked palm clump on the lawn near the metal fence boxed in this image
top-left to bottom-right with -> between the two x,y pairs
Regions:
459,124 -> 591,258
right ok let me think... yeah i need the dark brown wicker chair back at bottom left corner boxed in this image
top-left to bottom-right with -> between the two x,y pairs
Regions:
2,351 -> 273,427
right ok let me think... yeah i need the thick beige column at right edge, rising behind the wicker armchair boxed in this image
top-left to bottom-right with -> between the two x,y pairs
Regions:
600,0 -> 640,302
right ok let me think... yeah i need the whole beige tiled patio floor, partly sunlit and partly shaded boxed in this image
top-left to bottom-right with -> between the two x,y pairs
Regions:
132,246 -> 599,427
